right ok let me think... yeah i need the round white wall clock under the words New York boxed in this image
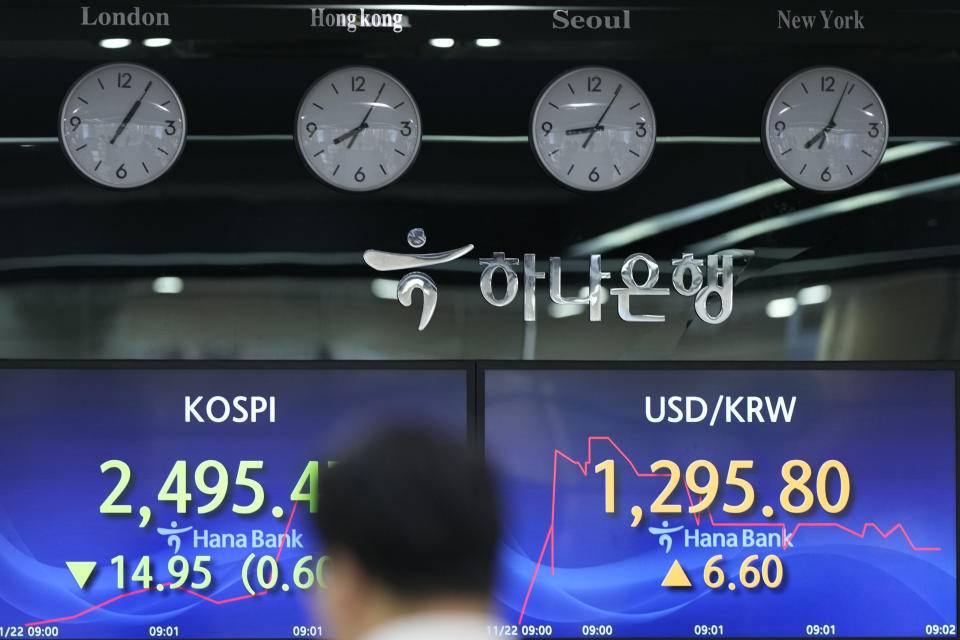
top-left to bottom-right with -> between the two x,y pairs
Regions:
763,67 -> 889,191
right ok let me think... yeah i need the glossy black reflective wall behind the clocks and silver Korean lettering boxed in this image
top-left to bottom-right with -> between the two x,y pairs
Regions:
0,3 -> 960,360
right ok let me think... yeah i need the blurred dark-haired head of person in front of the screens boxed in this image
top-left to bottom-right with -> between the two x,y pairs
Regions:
317,427 -> 499,640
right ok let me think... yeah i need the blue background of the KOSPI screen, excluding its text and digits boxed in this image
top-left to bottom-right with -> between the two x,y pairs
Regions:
0,370 -> 467,638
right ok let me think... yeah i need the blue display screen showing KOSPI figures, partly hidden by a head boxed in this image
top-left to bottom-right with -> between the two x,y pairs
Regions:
0,368 -> 468,638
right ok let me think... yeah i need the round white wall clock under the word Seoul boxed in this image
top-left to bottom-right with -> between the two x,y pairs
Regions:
530,67 -> 657,191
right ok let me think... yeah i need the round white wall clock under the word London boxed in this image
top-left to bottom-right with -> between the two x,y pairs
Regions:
60,63 -> 186,189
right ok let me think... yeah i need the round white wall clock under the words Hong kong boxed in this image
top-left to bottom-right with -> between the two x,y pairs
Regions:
294,67 -> 421,191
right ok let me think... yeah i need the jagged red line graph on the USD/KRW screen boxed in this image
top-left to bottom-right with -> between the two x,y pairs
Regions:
517,436 -> 941,624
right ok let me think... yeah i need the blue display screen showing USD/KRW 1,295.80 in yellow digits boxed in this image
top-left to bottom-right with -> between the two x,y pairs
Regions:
484,370 -> 957,637
